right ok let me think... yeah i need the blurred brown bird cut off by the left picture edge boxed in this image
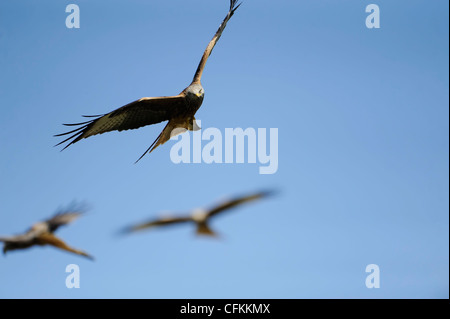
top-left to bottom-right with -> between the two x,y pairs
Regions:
0,205 -> 94,259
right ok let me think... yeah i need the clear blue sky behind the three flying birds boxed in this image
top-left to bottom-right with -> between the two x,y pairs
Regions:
0,0 -> 449,298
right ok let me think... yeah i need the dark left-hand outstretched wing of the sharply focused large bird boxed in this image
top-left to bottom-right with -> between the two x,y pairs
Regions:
55,94 -> 186,150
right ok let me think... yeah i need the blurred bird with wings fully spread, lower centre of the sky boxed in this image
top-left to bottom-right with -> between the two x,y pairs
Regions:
122,191 -> 273,236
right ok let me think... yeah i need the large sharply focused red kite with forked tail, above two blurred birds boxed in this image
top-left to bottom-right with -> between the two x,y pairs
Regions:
55,0 -> 241,163
